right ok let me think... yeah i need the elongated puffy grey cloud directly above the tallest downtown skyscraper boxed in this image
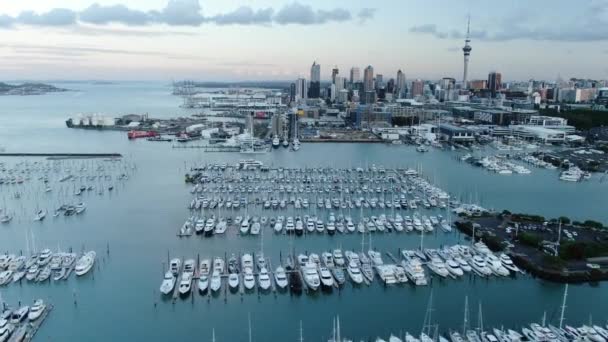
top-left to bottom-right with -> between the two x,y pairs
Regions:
274,2 -> 352,25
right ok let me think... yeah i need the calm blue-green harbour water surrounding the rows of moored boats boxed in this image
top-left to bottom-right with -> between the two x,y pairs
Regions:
0,82 -> 608,341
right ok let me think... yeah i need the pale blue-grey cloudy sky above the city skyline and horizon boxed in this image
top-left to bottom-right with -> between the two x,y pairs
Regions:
0,0 -> 608,81
